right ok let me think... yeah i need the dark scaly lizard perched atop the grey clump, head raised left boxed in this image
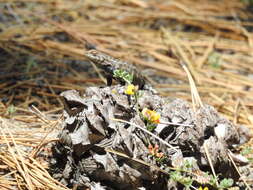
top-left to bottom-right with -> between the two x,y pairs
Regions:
85,49 -> 156,93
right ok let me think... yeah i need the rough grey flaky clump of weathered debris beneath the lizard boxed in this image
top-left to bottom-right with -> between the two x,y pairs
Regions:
51,85 -> 247,189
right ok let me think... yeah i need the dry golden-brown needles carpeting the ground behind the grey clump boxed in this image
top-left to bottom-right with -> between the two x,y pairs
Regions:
0,0 -> 253,189
